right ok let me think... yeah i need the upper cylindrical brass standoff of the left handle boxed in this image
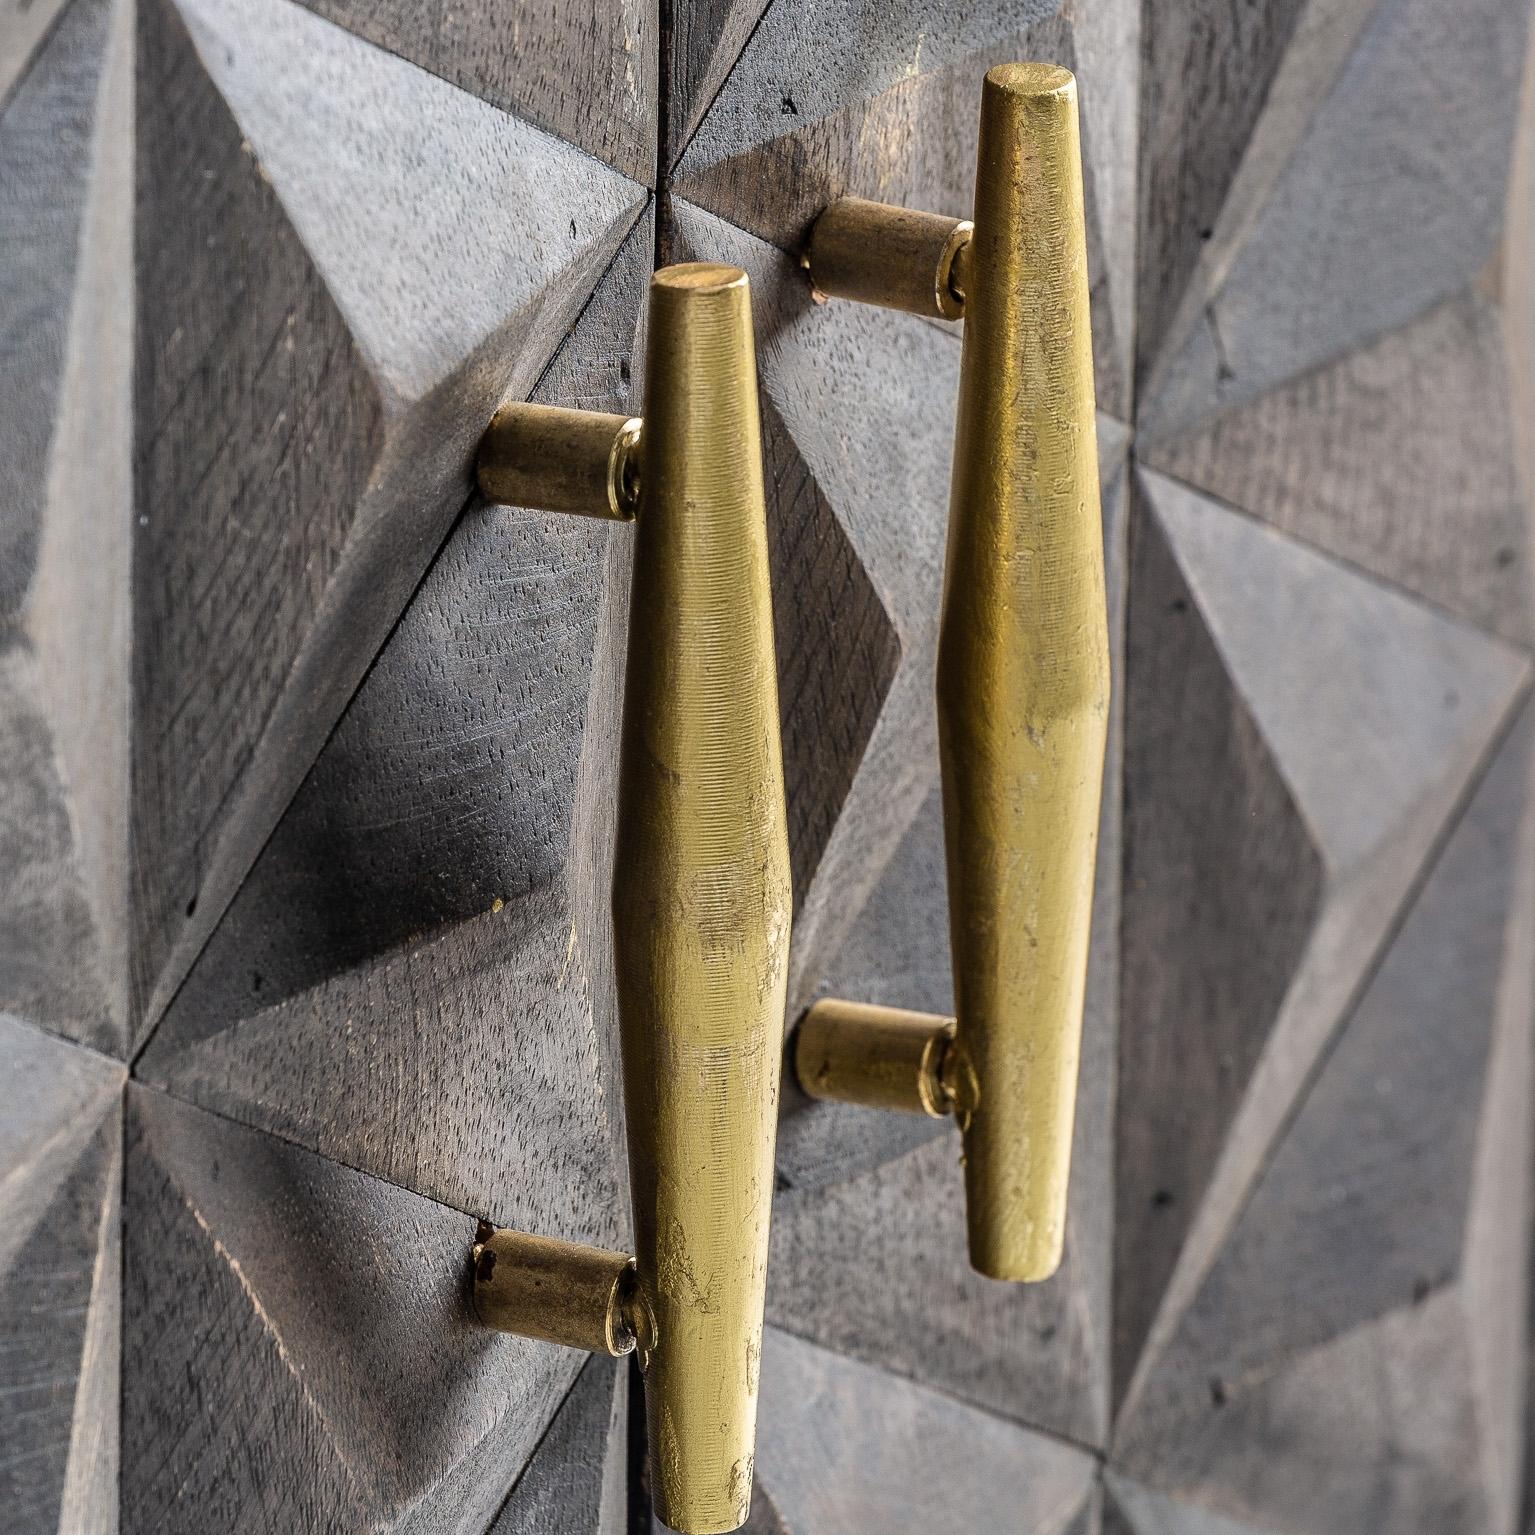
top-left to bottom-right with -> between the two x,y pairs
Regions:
474,401 -> 640,522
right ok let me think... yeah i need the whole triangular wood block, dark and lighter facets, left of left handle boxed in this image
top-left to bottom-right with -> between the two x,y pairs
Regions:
143,220 -> 651,1245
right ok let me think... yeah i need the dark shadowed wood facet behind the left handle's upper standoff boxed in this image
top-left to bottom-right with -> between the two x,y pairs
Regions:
152,216 -> 652,1031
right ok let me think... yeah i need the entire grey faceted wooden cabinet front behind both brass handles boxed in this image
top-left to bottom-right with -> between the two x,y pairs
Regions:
0,0 -> 1535,1535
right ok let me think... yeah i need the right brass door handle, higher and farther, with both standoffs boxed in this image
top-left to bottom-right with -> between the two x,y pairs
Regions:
795,64 -> 1108,1280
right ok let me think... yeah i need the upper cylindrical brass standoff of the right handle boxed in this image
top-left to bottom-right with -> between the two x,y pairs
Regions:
804,196 -> 970,319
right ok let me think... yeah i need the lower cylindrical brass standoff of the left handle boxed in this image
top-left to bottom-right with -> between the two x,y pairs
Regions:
473,1226 -> 635,1355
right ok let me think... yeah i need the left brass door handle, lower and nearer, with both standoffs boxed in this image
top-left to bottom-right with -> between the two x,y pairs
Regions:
474,264 -> 792,1535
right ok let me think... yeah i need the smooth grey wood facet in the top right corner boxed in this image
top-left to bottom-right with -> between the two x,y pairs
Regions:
1137,0 -> 1529,437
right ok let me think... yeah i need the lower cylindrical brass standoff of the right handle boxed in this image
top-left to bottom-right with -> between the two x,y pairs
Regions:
794,998 -> 955,1119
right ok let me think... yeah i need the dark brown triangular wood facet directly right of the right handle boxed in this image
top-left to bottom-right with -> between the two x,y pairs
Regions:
1114,497 -> 1323,1391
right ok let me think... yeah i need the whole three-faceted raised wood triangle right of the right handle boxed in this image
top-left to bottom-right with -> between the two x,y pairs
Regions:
1116,474 -> 1529,1418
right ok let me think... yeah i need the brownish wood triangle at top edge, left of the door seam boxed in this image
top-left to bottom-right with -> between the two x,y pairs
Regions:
294,0 -> 660,183
